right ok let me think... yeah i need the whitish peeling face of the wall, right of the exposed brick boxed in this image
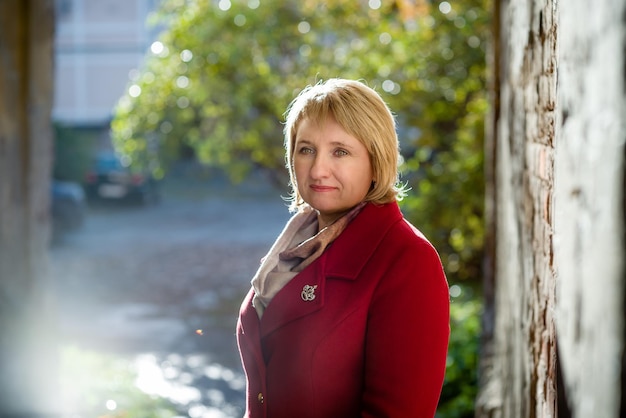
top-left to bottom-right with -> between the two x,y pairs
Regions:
554,0 -> 626,418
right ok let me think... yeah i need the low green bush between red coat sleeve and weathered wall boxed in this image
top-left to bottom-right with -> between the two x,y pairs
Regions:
436,285 -> 482,418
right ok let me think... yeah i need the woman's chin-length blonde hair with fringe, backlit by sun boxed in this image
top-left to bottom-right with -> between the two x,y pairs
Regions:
284,78 -> 406,212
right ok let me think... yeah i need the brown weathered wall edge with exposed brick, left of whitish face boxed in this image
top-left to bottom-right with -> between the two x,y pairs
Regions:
478,1 -> 557,417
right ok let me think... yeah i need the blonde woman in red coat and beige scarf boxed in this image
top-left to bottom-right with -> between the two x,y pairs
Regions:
237,79 -> 450,418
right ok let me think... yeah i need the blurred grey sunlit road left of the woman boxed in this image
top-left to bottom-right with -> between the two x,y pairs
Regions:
50,172 -> 289,418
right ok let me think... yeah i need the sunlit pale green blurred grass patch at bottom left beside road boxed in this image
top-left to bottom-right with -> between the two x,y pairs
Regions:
60,346 -> 180,418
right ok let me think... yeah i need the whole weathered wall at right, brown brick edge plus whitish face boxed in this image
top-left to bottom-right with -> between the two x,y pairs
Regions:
477,0 -> 626,418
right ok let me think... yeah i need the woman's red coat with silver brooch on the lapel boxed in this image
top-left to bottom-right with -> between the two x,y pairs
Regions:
237,203 -> 450,418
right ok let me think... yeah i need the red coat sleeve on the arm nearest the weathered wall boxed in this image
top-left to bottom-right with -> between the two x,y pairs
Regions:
361,230 -> 450,418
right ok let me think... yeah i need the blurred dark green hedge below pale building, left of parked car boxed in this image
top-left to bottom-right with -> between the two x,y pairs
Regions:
52,124 -> 100,183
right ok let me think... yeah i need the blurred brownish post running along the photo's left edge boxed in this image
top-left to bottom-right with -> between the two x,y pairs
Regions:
0,0 -> 58,417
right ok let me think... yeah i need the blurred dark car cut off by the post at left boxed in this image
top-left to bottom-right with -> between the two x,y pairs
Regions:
51,180 -> 86,239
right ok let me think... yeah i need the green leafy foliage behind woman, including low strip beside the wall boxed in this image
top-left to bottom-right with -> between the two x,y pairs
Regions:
112,0 -> 491,416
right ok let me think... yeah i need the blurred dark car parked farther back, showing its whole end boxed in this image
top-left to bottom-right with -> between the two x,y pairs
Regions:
85,153 -> 160,204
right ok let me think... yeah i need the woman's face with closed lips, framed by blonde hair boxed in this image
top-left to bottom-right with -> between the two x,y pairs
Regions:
293,116 -> 373,229
